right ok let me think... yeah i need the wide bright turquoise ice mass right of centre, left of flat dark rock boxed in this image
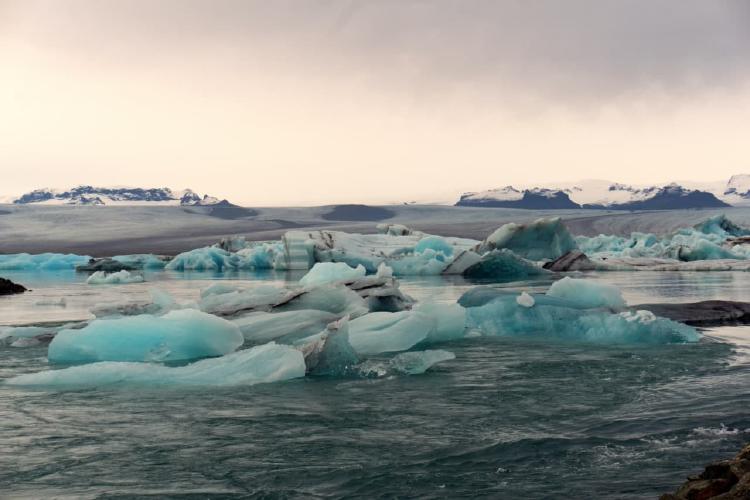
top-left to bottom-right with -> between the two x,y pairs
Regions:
466,293 -> 700,344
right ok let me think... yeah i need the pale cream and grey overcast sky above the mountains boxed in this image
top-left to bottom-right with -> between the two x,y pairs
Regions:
0,0 -> 750,206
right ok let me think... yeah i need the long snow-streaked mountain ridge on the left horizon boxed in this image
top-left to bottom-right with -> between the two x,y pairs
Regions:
13,186 -> 228,206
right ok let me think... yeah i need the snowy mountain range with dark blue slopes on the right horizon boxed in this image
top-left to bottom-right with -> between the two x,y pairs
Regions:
456,174 -> 750,210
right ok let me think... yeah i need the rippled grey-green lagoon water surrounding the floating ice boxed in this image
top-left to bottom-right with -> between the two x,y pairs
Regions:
0,273 -> 750,499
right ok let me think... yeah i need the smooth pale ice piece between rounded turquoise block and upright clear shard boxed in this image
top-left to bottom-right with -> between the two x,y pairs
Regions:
231,309 -> 339,344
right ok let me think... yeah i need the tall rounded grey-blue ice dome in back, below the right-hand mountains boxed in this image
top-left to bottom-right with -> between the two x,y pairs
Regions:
479,217 -> 577,260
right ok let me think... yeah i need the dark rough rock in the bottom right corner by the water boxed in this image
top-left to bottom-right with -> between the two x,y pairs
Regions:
661,445 -> 750,500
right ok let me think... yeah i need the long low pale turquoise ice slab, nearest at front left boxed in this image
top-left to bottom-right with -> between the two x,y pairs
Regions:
5,342 -> 305,389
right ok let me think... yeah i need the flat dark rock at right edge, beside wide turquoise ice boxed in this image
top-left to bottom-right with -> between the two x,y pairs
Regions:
633,300 -> 750,327
